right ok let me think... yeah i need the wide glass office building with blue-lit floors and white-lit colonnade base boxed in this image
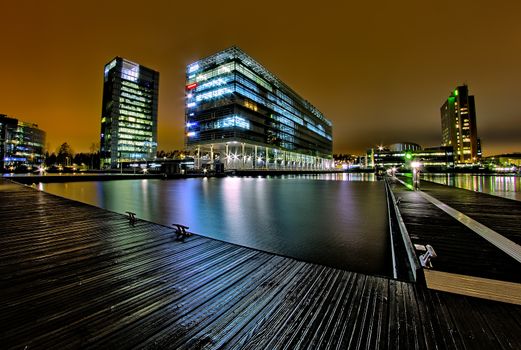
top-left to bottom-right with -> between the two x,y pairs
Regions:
185,47 -> 333,169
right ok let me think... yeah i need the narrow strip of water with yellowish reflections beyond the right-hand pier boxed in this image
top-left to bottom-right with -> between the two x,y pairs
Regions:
422,174 -> 521,201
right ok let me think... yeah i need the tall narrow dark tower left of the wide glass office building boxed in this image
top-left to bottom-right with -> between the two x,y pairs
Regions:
100,57 -> 159,168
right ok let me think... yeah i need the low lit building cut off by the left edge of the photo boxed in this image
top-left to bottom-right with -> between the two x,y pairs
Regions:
0,114 -> 46,171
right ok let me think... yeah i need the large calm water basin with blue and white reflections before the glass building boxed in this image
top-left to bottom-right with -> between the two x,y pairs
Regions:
40,174 -> 391,276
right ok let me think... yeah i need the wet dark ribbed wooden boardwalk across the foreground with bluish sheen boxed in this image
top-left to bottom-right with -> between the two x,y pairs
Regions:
0,180 -> 521,349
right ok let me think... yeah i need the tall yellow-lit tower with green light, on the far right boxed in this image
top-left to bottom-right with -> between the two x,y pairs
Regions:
440,85 -> 479,164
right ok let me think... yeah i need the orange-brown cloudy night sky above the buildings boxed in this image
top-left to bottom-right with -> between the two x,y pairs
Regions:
0,0 -> 521,155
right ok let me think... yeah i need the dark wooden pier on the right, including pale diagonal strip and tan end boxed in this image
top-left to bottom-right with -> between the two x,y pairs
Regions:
392,177 -> 521,304
